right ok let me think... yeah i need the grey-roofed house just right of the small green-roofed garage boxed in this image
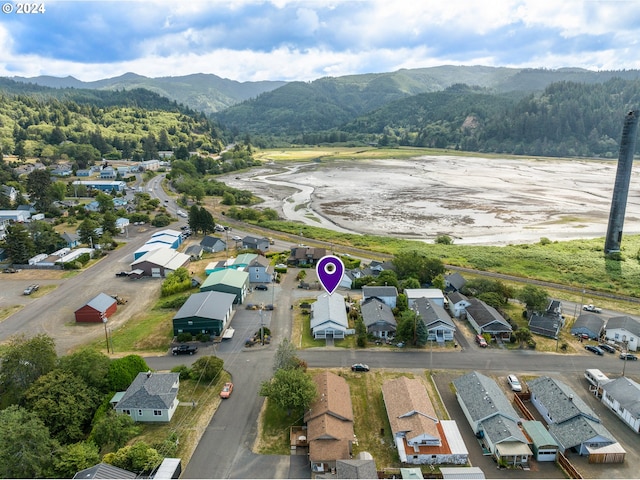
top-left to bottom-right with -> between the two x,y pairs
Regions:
527,377 -> 617,455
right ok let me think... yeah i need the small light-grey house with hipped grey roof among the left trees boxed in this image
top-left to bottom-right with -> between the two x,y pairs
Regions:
115,371 -> 180,423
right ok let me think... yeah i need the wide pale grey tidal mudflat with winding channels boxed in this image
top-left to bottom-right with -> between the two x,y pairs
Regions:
223,156 -> 640,245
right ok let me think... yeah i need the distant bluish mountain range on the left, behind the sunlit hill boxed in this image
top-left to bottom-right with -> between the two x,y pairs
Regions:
8,73 -> 286,114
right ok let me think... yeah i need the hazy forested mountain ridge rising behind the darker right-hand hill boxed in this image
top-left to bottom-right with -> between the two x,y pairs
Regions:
214,66 -> 640,136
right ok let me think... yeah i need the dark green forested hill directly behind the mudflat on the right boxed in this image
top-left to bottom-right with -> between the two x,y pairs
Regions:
344,79 -> 640,158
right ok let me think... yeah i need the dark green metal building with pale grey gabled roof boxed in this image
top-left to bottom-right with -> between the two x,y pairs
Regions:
173,291 -> 236,337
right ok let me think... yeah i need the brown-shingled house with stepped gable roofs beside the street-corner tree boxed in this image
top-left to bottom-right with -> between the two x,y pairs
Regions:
304,371 -> 355,473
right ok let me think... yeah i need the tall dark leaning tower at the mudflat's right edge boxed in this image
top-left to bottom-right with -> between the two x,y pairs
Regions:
604,110 -> 638,253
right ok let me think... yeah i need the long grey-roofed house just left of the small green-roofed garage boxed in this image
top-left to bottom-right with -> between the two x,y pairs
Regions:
453,372 -> 533,465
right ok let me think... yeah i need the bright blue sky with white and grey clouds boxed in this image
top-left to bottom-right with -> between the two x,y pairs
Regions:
0,0 -> 640,82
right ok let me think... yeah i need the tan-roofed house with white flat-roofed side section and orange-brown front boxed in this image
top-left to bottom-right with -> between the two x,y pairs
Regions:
382,377 -> 469,465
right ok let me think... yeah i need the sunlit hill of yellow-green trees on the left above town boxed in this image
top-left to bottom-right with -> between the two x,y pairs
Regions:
0,89 -> 224,168
